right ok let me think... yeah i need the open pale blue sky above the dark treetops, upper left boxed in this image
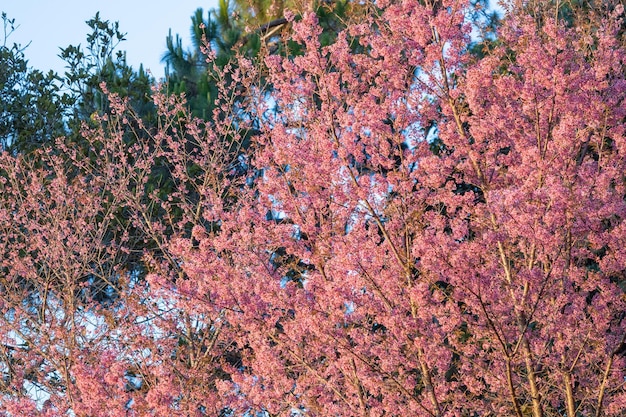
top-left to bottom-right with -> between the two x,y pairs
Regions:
0,0 -> 217,78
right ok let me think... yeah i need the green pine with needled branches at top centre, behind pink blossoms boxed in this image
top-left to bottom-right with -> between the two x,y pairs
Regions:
162,0 -> 356,120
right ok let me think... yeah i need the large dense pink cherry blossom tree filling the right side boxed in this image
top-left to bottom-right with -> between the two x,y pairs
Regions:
178,2 -> 625,416
